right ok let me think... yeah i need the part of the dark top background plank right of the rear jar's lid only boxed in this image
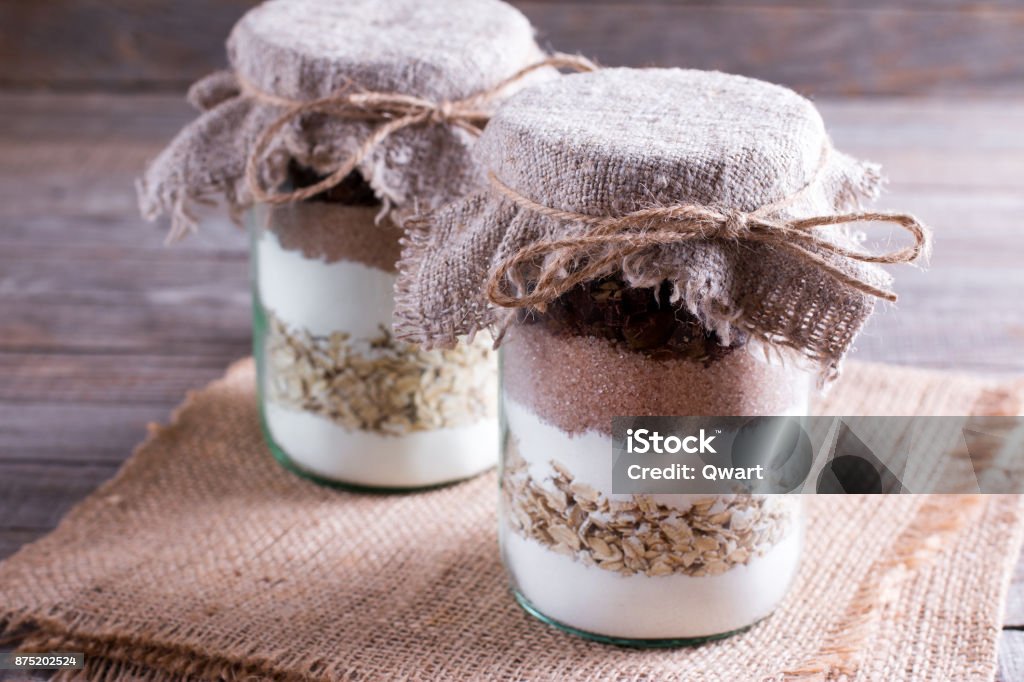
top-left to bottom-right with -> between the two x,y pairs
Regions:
518,2 -> 1024,94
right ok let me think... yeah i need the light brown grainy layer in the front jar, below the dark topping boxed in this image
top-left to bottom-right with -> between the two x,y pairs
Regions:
501,325 -> 812,434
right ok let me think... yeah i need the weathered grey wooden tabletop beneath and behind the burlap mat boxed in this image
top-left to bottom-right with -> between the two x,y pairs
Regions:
0,94 -> 1024,680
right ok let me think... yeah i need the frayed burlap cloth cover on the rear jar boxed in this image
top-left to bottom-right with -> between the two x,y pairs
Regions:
138,0 -> 554,237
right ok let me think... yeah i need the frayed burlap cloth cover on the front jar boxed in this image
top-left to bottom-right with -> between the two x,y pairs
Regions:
396,69 -> 925,374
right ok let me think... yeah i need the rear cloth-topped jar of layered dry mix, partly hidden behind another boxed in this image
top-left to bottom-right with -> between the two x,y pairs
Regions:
139,0 -> 588,488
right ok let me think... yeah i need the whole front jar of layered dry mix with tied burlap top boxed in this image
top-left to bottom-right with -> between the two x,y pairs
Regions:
396,69 -> 928,645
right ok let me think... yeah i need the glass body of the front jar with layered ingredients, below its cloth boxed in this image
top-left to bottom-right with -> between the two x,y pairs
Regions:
500,280 -> 814,646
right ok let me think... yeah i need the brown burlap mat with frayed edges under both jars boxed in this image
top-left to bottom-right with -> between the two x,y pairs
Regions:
0,360 -> 1024,682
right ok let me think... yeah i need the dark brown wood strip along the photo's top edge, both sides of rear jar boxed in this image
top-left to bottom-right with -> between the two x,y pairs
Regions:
0,0 -> 1024,94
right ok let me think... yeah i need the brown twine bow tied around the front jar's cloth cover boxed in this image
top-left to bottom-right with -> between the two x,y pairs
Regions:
487,168 -> 931,311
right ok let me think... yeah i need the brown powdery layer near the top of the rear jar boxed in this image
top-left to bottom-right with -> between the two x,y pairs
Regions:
266,201 -> 401,272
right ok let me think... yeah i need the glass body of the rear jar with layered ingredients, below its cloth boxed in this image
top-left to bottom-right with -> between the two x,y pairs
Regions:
249,173 -> 498,488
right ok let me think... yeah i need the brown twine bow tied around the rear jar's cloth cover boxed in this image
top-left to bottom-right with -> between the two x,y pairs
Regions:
239,54 -> 597,204
